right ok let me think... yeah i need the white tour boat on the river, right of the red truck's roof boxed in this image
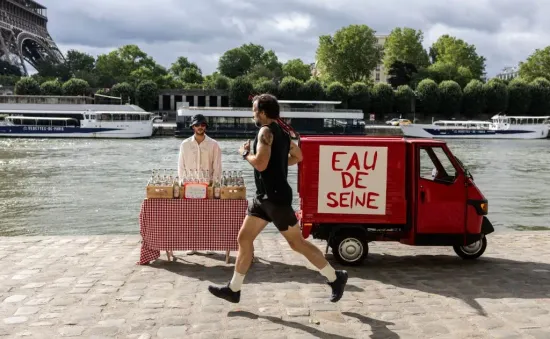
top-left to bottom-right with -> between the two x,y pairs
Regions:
400,114 -> 550,139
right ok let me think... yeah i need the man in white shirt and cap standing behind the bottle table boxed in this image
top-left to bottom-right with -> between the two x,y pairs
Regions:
178,114 -> 222,254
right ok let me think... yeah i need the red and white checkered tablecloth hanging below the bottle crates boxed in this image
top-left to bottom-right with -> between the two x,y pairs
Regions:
138,199 -> 248,265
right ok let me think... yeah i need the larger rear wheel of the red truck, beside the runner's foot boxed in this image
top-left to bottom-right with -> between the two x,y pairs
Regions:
331,234 -> 369,266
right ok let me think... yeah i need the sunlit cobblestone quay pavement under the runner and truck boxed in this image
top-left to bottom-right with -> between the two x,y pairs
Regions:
0,232 -> 550,339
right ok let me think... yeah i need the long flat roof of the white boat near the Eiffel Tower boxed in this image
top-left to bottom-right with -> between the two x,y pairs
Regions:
0,103 -> 148,114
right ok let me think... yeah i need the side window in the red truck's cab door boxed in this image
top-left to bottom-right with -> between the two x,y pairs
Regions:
419,146 -> 458,183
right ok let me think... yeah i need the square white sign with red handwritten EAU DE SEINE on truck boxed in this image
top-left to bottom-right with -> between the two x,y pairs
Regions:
317,146 -> 388,215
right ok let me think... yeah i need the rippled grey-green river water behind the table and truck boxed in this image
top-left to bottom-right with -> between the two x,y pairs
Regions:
0,137 -> 550,236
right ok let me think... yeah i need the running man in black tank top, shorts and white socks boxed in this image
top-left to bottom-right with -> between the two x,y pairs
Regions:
208,94 -> 348,303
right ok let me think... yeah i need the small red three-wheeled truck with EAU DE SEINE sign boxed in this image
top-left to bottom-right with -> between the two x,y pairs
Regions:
298,136 -> 494,265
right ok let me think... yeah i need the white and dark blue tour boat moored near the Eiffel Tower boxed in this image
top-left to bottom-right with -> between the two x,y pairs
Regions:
0,104 -> 158,139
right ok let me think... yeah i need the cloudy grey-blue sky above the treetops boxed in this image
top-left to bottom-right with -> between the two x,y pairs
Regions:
44,0 -> 550,77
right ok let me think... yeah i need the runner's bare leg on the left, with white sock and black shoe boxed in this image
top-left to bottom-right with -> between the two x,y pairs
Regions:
208,215 -> 269,303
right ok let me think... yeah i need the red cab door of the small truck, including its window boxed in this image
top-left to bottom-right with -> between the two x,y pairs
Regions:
415,145 -> 467,239
